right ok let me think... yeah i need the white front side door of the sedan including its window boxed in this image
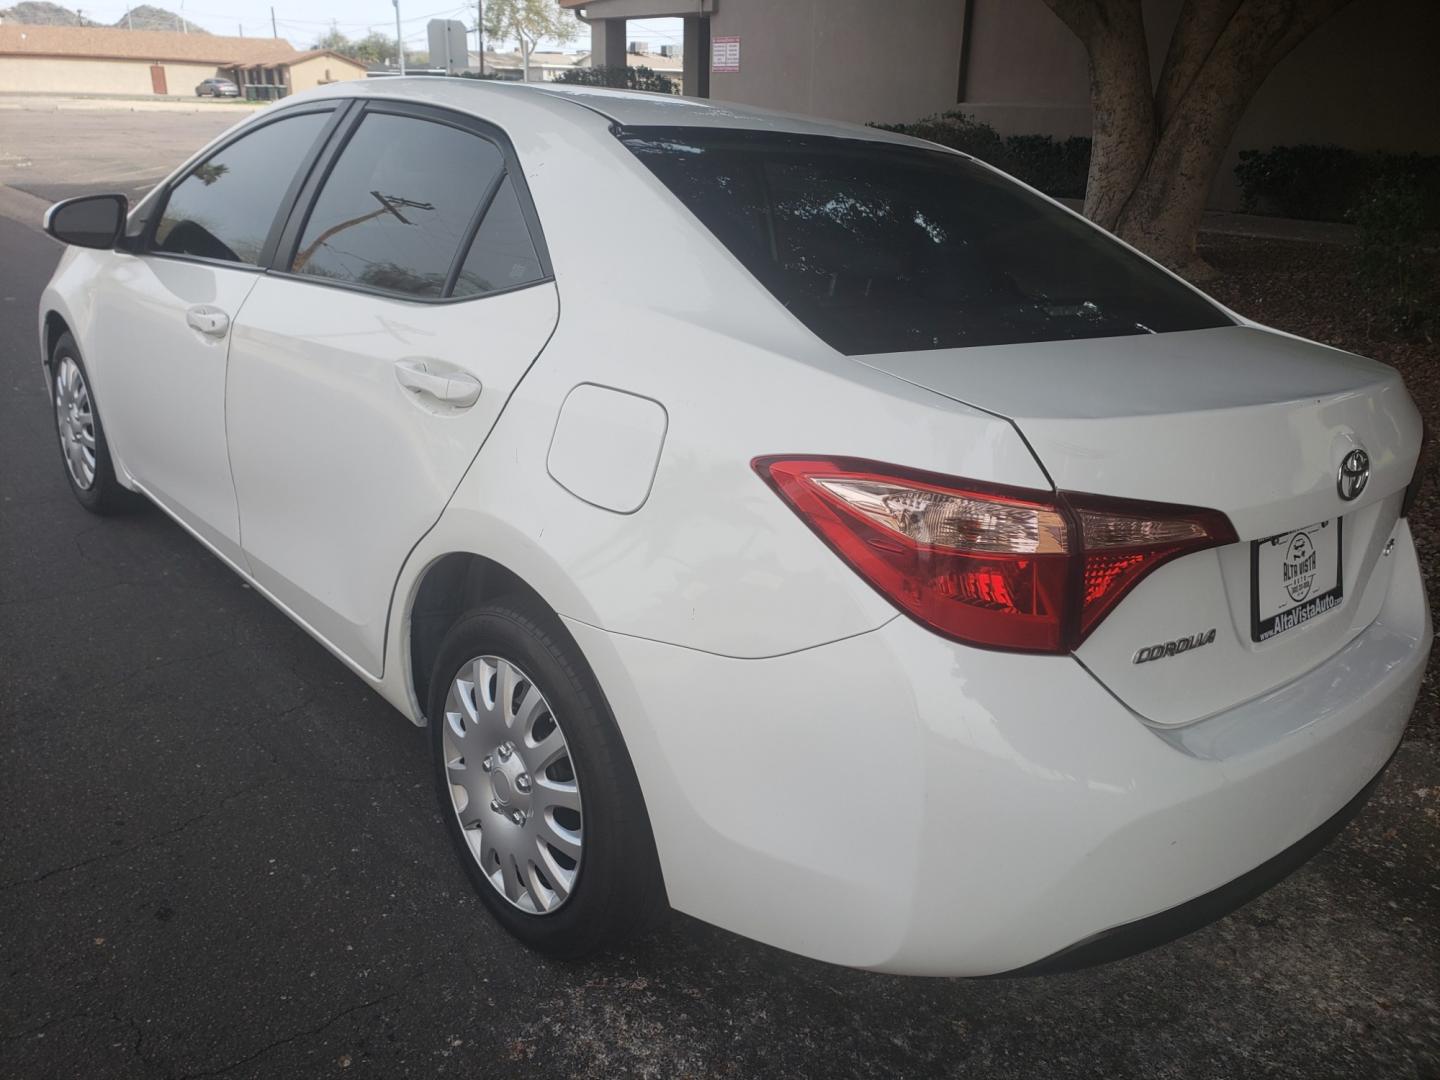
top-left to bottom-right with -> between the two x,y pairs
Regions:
86,107 -> 342,562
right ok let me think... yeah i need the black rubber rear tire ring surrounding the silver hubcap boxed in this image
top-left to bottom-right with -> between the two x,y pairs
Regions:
426,603 -> 664,958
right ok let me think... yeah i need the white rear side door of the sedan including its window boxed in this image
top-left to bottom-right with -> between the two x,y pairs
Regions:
226,102 -> 559,675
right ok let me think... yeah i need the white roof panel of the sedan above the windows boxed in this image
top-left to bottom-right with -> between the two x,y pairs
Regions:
298,75 -> 932,145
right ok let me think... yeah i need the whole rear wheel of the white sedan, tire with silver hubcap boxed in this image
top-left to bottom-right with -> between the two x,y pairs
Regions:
426,598 -> 668,959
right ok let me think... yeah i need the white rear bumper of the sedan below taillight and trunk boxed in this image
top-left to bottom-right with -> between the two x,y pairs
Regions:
569,521 -> 1431,975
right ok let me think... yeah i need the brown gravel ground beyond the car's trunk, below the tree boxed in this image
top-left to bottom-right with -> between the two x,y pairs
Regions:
1201,235 -> 1440,742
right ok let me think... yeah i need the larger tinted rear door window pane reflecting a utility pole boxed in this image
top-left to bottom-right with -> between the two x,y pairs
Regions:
291,114 -> 504,297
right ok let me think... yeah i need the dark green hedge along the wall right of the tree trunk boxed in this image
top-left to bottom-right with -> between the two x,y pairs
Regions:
1236,145 -> 1440,229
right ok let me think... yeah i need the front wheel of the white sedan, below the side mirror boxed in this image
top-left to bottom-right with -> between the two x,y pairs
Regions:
49,331 -> 141,514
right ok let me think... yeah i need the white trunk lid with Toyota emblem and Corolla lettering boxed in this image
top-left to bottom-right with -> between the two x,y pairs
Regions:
857,325 -> 1420,724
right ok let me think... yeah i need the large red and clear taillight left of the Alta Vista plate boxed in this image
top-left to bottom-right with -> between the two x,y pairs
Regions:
752,456 -> 1236,652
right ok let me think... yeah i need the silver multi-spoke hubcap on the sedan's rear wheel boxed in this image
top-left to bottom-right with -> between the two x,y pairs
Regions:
441,657 -> 583,914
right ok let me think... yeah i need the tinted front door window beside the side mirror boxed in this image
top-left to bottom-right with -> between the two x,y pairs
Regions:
154,112 -> 330,265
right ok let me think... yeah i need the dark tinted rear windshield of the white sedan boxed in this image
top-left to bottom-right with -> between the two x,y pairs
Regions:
619,127 -> 1231,356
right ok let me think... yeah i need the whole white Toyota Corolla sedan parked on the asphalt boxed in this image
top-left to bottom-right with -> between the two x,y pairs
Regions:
39,78 -> 1431,975
